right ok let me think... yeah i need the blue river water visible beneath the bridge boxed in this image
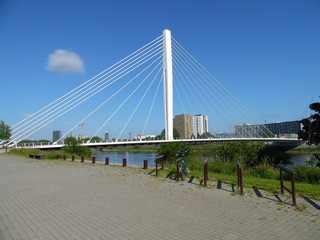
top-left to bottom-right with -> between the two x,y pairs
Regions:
92,151 -> 311,167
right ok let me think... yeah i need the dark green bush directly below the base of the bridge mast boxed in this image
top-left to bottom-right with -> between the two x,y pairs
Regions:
158,142 -> 191,163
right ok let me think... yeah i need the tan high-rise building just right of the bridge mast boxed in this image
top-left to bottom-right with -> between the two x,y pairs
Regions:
173,114 -> 193,139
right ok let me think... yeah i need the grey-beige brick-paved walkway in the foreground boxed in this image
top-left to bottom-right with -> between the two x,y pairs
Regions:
0,154 -> 320,240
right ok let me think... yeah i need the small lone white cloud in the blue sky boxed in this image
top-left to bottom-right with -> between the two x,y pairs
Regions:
47,49 -> 84,73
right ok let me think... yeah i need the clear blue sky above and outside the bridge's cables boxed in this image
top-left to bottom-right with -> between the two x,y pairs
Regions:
0,0 -> 320,139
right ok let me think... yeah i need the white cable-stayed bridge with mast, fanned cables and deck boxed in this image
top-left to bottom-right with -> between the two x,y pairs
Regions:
2,30 -> 299,148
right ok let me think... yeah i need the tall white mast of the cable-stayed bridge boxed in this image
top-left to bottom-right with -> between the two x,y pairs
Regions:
163,29 -> 173,140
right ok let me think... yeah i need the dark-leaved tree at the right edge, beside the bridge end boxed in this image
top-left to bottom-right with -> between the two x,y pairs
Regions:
299,102 -> 320,145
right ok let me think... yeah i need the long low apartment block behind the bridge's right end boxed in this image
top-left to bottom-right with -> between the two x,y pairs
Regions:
235,121 -> 301,138
